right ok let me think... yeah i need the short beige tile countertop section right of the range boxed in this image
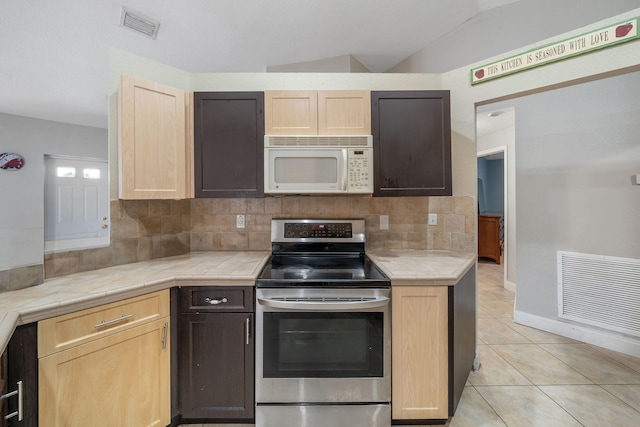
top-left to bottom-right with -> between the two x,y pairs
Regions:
367,250 -> 477,286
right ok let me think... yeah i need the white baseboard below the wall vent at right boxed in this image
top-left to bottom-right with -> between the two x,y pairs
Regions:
513,310 -> 640,357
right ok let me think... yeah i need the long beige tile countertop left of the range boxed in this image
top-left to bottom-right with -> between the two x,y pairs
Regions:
0,251 -> 270,352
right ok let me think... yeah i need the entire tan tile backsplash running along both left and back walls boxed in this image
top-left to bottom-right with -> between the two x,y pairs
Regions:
0,196 -> 476,291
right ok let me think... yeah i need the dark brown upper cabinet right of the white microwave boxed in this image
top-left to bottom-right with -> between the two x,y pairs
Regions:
371,90 -> 452,197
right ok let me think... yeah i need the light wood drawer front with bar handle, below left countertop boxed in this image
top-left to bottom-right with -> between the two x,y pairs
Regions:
38,290 -> 169,357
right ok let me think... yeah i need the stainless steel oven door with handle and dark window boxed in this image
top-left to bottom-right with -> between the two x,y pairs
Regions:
256,288 -> 391,404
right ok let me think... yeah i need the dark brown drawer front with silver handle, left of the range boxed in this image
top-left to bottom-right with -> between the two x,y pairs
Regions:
180,286 -> 253,313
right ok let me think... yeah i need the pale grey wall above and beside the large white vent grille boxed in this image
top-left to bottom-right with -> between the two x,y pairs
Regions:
514,72 -> 640,314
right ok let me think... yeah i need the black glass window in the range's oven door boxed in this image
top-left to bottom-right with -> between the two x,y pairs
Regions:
263,312 -> 384,378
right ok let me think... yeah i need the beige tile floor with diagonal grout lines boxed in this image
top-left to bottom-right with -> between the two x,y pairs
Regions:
181,261 -> 640,427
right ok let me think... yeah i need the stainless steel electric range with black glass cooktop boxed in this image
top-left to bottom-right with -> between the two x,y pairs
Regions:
256,219 -> 391,427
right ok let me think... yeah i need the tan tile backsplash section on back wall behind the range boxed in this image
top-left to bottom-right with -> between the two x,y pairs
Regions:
191,196 -> 475,252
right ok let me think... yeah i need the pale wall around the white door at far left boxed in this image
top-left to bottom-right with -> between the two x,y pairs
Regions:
0,113 -> 107,270
